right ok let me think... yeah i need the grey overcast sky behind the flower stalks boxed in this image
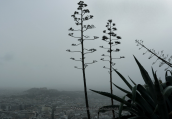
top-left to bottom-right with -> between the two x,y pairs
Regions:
0,0 -> 172,92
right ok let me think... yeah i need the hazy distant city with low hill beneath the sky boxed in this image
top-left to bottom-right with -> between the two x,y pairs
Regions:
0,87 -> 129,119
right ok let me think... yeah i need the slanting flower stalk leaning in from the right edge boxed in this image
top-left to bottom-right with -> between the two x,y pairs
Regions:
135,40 -> 172,71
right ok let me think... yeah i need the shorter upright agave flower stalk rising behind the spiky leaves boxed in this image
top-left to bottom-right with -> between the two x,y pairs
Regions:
100,19 -> 125,118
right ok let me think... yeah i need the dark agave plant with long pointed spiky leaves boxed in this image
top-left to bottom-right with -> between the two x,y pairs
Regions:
91,56 -> 172,119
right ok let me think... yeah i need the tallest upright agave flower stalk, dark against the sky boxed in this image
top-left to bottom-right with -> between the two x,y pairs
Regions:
67,1 -> 98,119
